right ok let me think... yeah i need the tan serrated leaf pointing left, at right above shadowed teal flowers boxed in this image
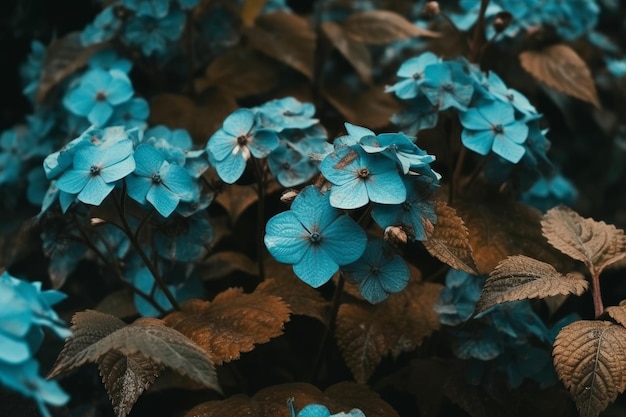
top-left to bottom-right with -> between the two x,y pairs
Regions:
476,255 -> 589,313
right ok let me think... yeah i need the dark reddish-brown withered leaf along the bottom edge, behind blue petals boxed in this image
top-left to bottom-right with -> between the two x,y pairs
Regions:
184,382 -> 398,417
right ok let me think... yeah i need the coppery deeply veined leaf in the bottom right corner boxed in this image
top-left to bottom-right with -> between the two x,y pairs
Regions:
553,320 -> 626,417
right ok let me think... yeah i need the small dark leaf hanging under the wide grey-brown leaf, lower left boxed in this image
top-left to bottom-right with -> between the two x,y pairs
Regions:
99,351 -> 163,417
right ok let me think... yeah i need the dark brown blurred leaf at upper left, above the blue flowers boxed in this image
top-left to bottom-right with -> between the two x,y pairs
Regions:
36,32 -> 106,102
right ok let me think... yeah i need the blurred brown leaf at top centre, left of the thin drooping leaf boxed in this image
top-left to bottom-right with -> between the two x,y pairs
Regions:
244,12 -> 315,78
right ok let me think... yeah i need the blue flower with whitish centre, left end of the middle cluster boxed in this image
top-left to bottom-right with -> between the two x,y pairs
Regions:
206,109 -> 278,184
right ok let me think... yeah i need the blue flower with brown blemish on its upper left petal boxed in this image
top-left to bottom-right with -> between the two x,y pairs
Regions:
320,146 -> 406,209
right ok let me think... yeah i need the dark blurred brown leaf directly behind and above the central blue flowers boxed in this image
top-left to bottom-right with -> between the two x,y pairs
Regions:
322,83 -> 401,129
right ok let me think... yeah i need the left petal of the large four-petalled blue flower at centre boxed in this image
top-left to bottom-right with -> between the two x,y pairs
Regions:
264,211 -> 311,264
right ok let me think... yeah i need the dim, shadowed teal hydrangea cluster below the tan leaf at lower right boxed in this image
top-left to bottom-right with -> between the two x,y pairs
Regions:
434,269 -> 578,388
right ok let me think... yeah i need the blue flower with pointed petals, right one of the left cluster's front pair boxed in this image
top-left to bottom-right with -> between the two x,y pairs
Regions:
125,144 -> 200,217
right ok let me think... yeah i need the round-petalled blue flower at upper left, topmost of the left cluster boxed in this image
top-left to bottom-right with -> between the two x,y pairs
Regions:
63,69 -> 134,126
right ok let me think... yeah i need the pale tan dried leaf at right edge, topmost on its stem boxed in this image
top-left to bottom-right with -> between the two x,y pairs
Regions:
541,206 -> 626,275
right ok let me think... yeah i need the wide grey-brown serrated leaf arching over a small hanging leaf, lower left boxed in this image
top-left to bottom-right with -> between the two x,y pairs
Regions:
49,310 -> 220,397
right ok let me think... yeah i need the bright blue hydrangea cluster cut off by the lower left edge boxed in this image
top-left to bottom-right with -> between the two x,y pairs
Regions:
0,272 -> 71,417
